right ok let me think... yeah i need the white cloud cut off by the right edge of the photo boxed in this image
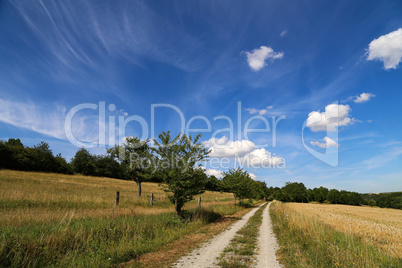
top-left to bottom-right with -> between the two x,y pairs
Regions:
367,28 -> 402,69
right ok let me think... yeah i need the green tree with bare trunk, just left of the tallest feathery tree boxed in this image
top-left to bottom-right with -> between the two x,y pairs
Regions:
108,137 -> 153,197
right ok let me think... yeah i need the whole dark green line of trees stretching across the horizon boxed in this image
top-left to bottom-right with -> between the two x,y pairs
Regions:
0,137 -> 402,214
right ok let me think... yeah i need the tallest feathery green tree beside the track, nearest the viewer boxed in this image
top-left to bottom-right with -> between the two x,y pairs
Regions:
154,131 -> 209,215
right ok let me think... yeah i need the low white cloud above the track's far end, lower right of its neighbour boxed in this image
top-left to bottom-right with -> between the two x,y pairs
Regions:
236,148 -> 283,168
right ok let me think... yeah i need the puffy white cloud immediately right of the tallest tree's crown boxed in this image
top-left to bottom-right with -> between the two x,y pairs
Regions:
202,136 -> 255,158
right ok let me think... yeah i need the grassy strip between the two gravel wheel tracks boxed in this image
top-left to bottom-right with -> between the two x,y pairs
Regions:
218,204 -> 268,268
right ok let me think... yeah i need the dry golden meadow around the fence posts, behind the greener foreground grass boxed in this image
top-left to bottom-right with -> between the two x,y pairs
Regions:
0,170 -> 233,226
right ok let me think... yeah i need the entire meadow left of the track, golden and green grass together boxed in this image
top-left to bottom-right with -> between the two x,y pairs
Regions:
0,170 -> 241,267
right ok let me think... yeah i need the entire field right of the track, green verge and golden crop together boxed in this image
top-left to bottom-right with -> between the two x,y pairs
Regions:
270,202 -> 402,268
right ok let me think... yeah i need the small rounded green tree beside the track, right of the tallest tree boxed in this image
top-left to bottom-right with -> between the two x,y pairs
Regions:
222,168 -> 253,204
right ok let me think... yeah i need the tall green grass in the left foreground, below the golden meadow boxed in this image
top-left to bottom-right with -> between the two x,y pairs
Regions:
0,206 -> 240,267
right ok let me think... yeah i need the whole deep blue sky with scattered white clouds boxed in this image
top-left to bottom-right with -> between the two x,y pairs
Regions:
0,0 -> 402,192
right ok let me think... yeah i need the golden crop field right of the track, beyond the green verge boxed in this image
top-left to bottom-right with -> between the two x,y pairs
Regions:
285,203 -> 402,257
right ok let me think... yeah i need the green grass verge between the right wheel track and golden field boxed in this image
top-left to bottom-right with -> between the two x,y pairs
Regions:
270,202 -> 402,268
